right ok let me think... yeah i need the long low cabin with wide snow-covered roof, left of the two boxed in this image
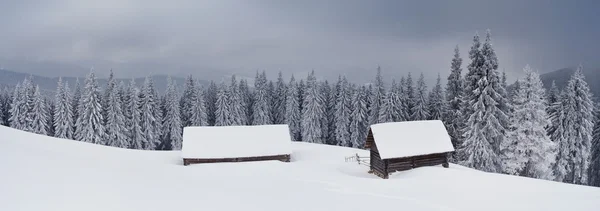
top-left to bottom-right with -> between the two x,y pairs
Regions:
181,125 -> 292,165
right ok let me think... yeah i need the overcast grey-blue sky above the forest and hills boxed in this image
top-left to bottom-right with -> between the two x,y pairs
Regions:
0,0 -> 600,82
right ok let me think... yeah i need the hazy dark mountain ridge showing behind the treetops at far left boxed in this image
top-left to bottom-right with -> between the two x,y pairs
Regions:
0,69 -> 210,94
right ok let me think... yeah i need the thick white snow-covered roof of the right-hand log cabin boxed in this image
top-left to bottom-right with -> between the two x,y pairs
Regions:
371,120 -> 454,159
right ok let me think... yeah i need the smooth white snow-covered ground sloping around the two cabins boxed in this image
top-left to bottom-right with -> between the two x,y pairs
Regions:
0,126 -> 600,211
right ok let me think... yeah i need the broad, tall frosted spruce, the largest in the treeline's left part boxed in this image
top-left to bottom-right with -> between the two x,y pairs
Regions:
75,70 -> 106,144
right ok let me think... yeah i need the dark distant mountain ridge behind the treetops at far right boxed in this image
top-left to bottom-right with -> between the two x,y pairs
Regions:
540,67 -> 600,101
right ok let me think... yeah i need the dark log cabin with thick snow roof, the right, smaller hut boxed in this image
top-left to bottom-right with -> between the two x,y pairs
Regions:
365,120 -> 454,179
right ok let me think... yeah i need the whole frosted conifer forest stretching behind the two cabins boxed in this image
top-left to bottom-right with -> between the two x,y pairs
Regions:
0,31 -> 600,187
